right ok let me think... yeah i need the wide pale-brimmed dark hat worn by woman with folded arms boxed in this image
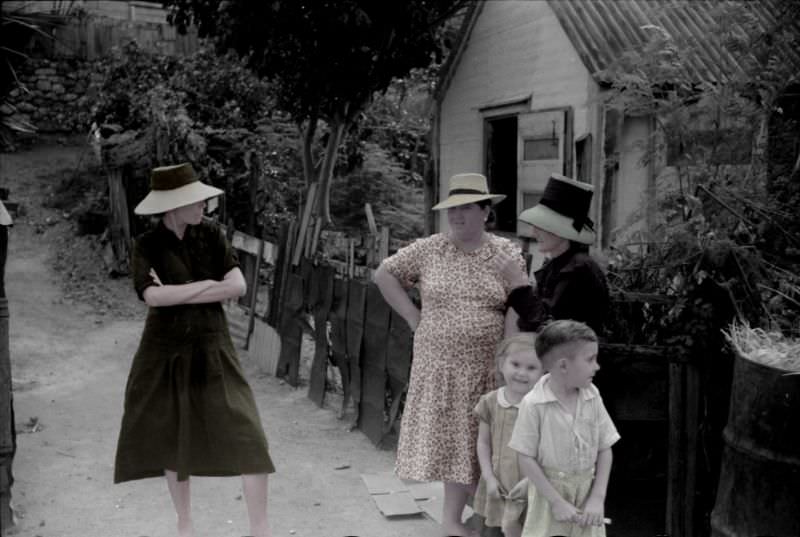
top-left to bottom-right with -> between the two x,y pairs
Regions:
133,163 -> 222,214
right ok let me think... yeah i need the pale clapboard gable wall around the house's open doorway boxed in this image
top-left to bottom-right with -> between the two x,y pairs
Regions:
438,0 -> 599,229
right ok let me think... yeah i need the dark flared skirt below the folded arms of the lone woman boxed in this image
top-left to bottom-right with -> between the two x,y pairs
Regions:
114,323 -> 275,483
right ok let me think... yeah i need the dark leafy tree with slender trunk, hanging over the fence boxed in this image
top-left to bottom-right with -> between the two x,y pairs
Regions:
163,0 -> 467,224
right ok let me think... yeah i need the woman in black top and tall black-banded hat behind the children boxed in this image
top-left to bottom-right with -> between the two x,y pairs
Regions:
504,175 -> 609,334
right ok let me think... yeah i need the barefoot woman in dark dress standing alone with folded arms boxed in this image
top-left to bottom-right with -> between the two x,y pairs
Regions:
114,164 -> 274,537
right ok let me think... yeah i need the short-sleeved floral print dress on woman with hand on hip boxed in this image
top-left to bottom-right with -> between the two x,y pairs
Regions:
383,233 -> 525,484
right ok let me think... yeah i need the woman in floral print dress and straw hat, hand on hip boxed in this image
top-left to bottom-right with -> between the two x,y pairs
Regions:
374,174 -> 525,536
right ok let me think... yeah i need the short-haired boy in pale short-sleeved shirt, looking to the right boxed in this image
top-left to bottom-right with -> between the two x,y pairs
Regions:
509,320 -> 619,537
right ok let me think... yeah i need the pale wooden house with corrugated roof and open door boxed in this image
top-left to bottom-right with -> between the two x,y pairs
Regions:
431,0 -> 796,246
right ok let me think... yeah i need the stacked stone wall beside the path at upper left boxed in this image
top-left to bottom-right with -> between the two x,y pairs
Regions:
0,58 -> 103,134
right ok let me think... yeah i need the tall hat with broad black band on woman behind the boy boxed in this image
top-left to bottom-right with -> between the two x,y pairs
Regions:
519,174 -> 595,244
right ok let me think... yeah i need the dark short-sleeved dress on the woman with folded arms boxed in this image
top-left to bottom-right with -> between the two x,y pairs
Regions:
114,222 -> 274,483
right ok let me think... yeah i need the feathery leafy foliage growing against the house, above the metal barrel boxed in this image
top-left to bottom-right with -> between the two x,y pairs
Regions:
603,3 -> 800,344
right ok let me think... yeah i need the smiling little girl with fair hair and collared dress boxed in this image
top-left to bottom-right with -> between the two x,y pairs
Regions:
472,332 -> 542,537
